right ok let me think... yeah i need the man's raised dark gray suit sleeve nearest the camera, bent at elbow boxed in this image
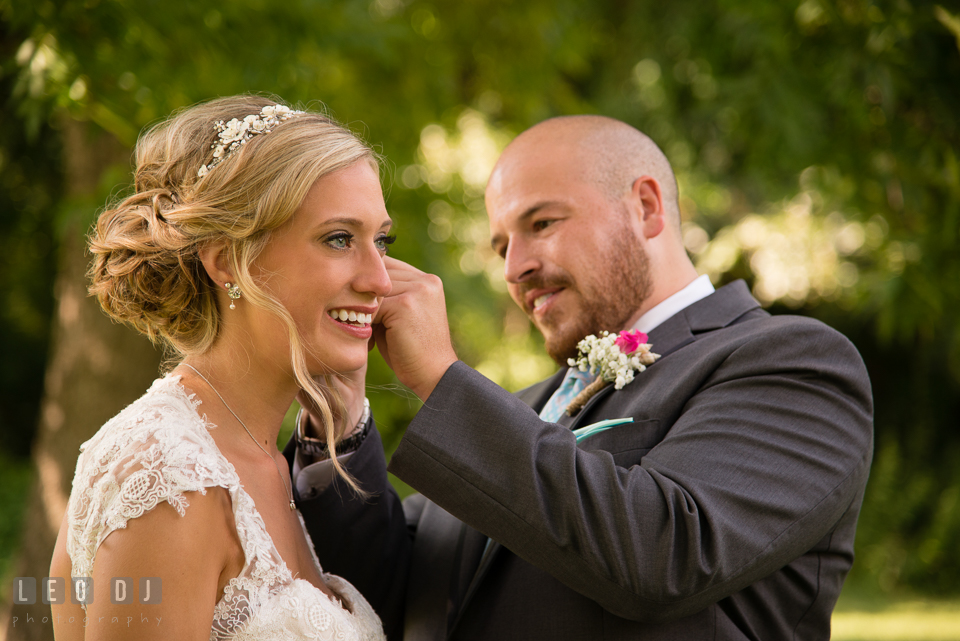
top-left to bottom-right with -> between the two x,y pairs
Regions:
390,321 -> 873,621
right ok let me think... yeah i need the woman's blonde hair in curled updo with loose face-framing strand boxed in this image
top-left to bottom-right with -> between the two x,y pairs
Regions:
89,95 -> 378,494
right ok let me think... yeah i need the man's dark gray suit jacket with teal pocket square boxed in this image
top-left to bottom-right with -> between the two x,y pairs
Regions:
296,282 -> 873,641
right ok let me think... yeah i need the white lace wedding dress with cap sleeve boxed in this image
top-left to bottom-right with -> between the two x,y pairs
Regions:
67,375 -> 384,641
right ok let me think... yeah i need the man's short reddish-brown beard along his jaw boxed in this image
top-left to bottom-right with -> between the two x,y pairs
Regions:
534,227 -> 653,367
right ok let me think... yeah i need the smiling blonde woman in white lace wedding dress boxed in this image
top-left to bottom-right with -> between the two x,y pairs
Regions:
50,96 -> 392,640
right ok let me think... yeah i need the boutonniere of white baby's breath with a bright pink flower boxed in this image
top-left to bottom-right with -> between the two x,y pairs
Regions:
567,330 -> 660,416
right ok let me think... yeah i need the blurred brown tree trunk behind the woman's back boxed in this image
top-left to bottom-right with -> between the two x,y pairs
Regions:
7,119 -> 160,641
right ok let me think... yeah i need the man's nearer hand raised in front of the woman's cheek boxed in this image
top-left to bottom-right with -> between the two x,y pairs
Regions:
372,256 -> 457,401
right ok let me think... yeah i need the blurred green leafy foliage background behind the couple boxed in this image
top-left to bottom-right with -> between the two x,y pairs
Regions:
0,0 -> 960,592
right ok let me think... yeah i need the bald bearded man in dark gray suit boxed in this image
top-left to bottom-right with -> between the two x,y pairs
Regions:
290,116 -> 872,640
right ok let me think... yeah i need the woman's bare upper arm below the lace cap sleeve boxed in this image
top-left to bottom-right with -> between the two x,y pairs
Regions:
50,487 -> 244,641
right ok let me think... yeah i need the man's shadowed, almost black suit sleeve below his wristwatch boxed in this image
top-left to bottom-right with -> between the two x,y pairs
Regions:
292,422 -> 412,640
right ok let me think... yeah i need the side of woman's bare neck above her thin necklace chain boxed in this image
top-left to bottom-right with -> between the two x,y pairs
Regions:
177,342 -> 299,451
